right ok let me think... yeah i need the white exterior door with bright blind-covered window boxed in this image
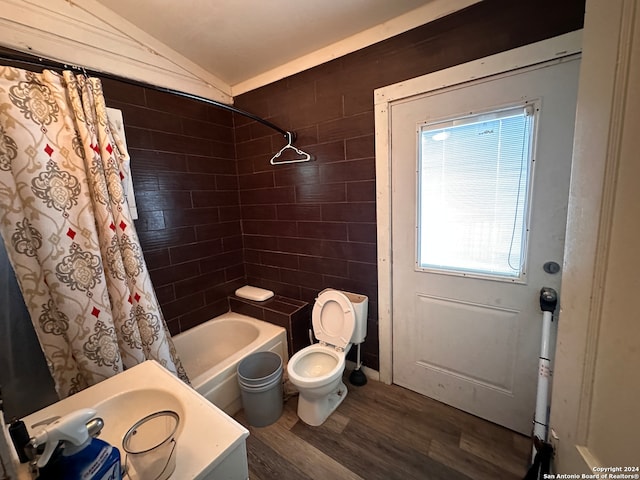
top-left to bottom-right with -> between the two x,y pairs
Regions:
390,58 -> 579,434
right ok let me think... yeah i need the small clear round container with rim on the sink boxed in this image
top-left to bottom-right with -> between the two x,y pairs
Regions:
122,410 -> 180,480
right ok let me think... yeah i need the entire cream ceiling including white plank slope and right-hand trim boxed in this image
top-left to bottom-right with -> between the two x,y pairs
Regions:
0,0 -> 480,103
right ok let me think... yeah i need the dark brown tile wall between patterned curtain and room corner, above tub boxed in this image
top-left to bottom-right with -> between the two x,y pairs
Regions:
103,80 -> 245,333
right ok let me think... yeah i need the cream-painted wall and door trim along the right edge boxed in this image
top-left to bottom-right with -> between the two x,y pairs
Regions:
551,0 -> 640,472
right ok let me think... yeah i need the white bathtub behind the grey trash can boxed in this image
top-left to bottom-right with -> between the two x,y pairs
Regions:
173,312 -> 288,415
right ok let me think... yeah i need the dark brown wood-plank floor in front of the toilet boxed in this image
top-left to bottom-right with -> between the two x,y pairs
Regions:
235,378 -> 531,480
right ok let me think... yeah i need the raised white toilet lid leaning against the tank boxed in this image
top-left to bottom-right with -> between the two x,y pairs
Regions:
311,290 -> 356,349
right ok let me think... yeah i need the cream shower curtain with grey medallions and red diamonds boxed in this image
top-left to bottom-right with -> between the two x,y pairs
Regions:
0,67 -> 188,398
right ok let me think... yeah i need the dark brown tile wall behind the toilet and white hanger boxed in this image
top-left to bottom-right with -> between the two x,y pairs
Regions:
234,0 -> 584,369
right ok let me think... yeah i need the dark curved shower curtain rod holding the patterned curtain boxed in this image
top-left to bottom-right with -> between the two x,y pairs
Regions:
0,47 -> 296,141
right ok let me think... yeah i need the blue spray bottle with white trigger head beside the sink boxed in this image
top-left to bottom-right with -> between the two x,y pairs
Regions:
31,408 -> 122,480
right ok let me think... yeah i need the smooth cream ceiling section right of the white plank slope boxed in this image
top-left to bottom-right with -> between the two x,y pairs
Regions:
98,0 -> 470,93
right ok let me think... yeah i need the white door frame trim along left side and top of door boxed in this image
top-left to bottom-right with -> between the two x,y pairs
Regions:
374,30 -> 582,384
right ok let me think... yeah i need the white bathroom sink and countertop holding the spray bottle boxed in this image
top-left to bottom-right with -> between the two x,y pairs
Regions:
20,361 -> 249,480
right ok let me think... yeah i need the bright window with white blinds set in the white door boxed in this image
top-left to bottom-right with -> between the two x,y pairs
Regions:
416,104 -> 538,282
